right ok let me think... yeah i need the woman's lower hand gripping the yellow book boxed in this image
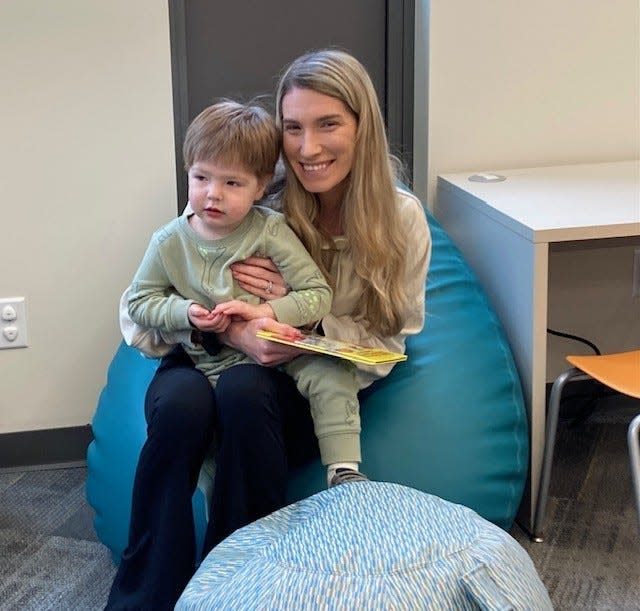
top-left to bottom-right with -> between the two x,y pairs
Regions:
220,318 -> 304,367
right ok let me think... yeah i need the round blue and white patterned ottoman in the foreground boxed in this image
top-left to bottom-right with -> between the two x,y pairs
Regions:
176,482 -> 553,611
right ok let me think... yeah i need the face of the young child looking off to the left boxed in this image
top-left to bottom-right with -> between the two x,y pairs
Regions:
189,161 -> 269,239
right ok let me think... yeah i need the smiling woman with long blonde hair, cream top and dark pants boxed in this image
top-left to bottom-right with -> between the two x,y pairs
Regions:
107,50 -> 431,610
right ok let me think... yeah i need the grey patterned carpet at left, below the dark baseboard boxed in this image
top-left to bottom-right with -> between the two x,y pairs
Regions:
0,469 -> 115,611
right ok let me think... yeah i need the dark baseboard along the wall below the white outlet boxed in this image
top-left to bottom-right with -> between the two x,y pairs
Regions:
0,424 -> 93,472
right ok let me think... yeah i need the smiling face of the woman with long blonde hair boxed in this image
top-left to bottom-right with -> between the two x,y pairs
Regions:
282,87 -> 358,206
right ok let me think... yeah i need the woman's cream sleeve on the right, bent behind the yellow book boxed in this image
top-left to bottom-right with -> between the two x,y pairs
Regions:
322,192 -> 431,388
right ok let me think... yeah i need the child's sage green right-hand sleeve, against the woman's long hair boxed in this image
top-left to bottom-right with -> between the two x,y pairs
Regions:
265,215 -> 332,327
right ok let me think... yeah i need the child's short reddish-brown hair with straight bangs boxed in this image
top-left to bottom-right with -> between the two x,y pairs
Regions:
182,99 -> 280,178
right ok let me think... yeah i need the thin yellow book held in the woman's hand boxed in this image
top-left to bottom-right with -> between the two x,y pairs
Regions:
256,331 -> 407,365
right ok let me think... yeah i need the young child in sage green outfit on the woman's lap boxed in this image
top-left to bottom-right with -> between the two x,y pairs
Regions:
128,101 -> 366,486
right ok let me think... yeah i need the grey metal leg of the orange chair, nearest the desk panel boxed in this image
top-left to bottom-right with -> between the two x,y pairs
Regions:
531,367 -> 589,542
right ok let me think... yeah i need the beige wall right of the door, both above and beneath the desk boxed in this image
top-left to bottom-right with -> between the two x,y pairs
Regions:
414,0 -> 640,379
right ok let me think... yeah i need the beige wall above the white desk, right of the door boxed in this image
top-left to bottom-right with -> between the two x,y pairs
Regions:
415,0 -> 640,207
